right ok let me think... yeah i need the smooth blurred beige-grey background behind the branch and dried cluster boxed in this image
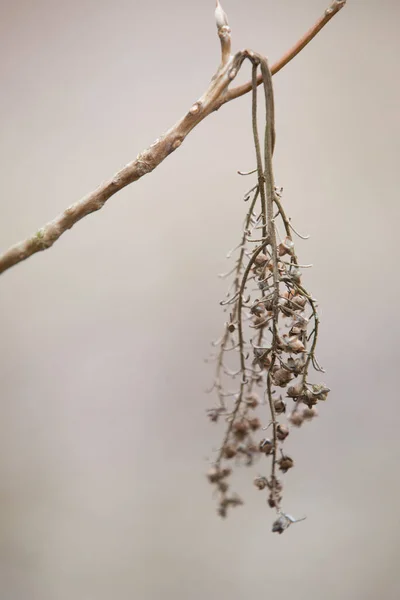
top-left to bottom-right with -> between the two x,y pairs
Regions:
0,0 -> 400,600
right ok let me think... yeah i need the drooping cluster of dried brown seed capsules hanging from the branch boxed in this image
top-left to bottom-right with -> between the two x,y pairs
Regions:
208,52 -> 329,533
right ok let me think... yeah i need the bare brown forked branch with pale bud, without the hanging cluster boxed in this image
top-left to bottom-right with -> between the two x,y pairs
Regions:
0,0 -> 346,273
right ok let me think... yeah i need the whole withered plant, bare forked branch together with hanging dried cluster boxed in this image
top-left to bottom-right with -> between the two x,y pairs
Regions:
0,0 -> 346,533
